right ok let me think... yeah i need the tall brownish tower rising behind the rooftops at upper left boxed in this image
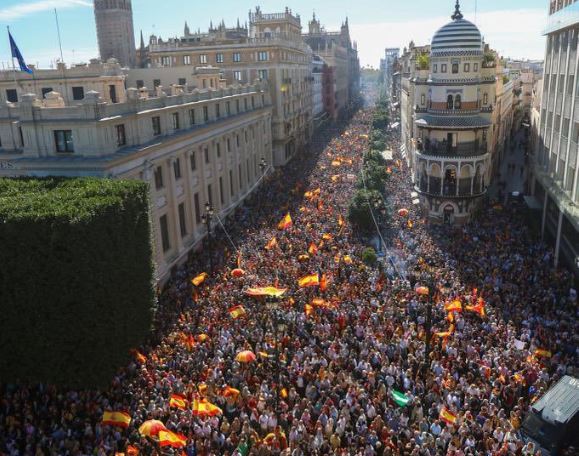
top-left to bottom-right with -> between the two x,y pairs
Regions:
94,0 -> 137,68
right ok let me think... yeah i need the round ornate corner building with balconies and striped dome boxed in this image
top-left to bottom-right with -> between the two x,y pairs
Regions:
402,0 -> 502,224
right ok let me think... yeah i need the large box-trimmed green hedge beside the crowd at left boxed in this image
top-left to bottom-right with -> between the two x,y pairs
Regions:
0,178 -> 154,387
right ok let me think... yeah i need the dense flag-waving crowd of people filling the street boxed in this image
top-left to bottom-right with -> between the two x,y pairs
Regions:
0,105 -> 579,456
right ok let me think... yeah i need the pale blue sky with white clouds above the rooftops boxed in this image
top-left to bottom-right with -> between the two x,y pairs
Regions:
0,0 -> 548,68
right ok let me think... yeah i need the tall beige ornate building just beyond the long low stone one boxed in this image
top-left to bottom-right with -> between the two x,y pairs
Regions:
148,8 -> 313,166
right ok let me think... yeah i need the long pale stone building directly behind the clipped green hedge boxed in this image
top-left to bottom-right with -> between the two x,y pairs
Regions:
0,74 -> 272,281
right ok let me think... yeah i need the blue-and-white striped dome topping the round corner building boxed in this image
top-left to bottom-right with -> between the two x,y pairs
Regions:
431,0 -> 483,53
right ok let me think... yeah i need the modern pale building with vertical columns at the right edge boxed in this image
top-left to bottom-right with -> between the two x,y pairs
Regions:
531,0 -> 579,273
